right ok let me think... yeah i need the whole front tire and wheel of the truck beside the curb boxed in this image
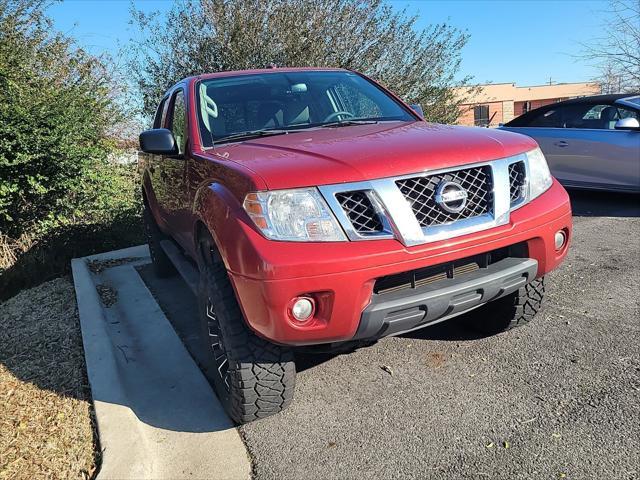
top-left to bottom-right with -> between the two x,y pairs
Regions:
198,234 -> 296,424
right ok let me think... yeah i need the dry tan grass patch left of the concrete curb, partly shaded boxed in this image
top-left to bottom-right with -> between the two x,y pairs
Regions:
0,278 -> 95,479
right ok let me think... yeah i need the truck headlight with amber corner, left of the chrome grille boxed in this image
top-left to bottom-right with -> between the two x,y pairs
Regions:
243,188 -> 347,242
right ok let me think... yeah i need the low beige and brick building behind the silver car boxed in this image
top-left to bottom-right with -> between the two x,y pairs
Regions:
457,82 -> 600,127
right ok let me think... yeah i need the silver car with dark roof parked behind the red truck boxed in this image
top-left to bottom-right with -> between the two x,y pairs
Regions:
500,94 -> 640,192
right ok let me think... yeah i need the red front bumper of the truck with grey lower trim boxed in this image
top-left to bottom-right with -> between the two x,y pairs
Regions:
222,181 -> 571,345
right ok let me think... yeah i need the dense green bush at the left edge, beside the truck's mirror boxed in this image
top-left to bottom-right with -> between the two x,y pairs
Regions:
0,0 -> 142,298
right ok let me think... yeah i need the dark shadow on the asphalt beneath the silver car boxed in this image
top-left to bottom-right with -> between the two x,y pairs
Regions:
568,189 -> 640,217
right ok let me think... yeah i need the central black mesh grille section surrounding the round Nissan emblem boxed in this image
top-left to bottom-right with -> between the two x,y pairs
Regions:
396,166 -> 493,227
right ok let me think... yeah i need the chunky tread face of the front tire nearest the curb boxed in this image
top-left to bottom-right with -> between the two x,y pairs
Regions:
202,263 -> 296,424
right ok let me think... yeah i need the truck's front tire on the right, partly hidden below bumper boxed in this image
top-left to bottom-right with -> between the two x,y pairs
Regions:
466,277 -> 544,335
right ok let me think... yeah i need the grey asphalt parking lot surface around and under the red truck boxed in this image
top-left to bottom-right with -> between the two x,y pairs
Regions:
141,192 -> 640,479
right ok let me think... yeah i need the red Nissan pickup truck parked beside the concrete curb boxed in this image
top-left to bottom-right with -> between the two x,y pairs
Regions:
140,68 -> 571,423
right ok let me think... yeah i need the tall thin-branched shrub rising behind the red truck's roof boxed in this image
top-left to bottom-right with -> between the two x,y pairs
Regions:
130,0 -> 470,123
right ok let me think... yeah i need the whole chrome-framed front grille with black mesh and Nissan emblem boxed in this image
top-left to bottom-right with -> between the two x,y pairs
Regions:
318,154 -> 528,246
